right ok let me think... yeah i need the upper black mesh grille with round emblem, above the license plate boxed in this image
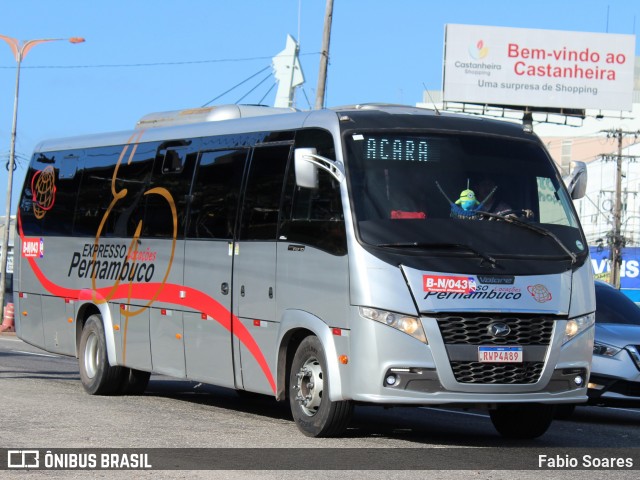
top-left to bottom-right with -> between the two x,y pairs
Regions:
438,316 -> 553,345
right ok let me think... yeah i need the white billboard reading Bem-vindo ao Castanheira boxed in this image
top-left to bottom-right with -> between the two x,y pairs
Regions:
443,24 -> 636,110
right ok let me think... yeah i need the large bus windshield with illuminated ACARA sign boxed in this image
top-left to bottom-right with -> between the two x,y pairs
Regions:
346,131 -> 586,261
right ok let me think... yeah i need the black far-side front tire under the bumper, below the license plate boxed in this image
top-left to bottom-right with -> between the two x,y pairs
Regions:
489,403 -> 555,439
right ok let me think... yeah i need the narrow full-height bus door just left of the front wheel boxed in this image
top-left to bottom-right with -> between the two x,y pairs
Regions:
233,144 -> 291,394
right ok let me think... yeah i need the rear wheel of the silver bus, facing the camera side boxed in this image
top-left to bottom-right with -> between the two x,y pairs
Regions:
78,315 -> 123,395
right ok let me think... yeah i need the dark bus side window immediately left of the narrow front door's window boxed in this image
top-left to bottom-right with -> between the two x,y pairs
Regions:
187,149 -> 248,240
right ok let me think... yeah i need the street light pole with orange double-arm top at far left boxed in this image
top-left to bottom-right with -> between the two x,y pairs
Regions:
0,35 -> 84,306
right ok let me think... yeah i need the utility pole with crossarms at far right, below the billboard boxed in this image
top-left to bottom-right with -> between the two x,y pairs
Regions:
601,128 -> 640,288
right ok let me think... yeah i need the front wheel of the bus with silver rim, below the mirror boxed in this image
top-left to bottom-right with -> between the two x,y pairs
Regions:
289,335 -> 353,437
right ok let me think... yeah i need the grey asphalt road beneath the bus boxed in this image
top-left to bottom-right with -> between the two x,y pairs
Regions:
0,335 -> 640,479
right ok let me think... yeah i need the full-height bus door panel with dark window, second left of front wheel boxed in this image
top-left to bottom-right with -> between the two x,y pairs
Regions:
183,148 -> 248,388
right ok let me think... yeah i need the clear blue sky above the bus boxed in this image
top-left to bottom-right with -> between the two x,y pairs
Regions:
0,0 -> 640,216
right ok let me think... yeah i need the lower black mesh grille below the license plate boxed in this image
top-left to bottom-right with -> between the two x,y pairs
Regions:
451,362 -> 544,384
